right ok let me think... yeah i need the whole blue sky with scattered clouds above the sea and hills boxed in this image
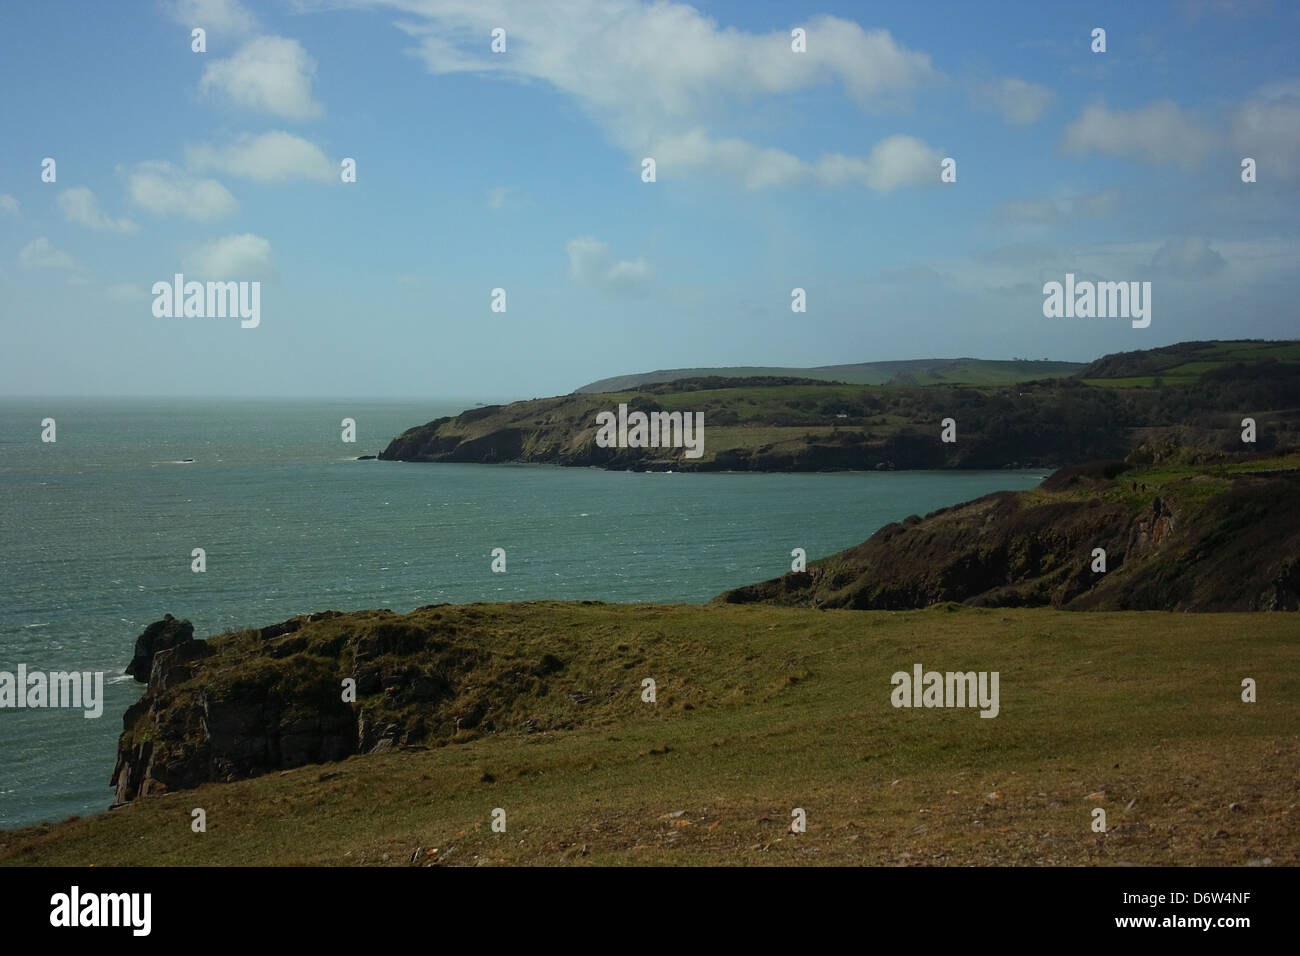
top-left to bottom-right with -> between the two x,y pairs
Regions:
0,0 -> 1300,401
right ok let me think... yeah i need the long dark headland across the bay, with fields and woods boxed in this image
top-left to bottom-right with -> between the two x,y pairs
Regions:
380,342 -> 1300,471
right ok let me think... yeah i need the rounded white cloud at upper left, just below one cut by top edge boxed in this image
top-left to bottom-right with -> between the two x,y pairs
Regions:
199,36 -> 324,120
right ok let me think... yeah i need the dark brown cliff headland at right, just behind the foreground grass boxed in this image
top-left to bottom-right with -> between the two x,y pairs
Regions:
715,462 -> 1300,611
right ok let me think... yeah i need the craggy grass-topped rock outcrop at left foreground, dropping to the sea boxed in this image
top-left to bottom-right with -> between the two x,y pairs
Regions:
111,602 -> 628,804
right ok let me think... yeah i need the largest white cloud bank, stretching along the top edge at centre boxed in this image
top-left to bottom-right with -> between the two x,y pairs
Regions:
380,0 -> 939,119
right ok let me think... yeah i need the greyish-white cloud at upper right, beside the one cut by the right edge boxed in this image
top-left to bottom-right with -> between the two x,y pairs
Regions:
1061,100 -> 1213,168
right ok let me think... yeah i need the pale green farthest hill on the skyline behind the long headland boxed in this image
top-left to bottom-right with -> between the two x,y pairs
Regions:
576,359 -> 1084,395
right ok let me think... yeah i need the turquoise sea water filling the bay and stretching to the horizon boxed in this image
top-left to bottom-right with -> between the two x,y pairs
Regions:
0,399 -> 1043,827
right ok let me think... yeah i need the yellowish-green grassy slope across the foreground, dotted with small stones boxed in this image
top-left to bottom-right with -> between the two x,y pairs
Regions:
0,602 -> 1300,866
